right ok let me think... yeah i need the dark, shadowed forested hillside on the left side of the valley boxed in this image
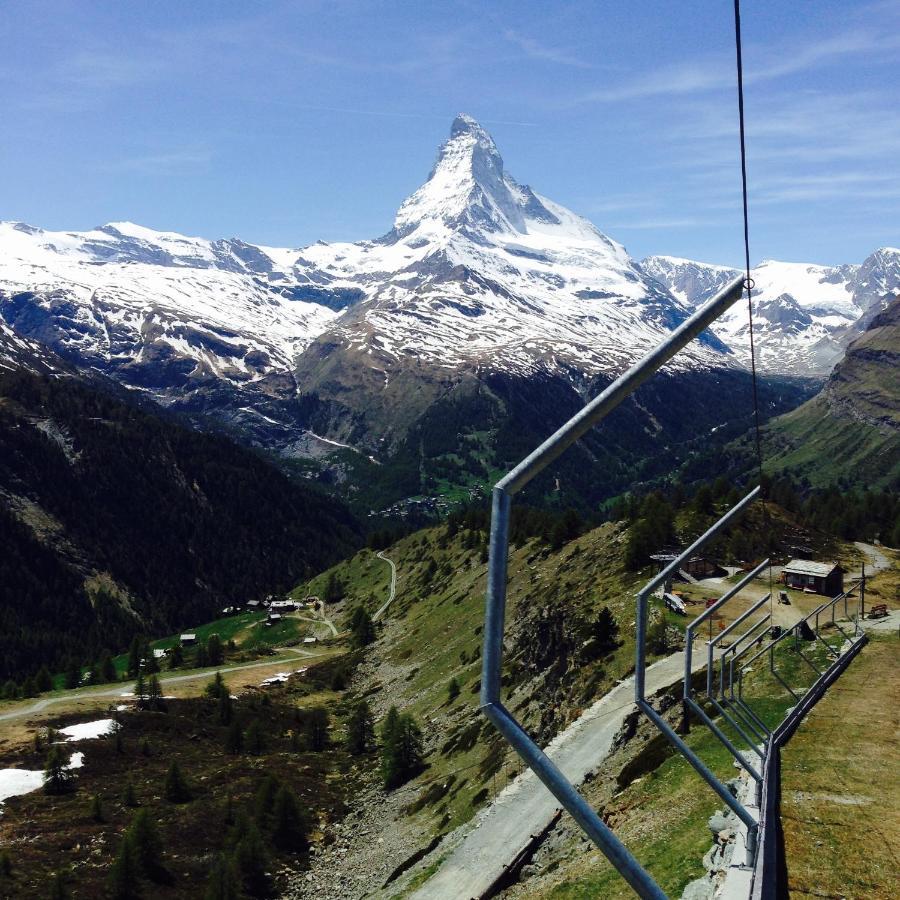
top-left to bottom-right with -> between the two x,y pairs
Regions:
0,371 -> 359,678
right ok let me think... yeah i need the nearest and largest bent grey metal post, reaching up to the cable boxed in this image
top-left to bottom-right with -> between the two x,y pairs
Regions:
481,277 -> 749,898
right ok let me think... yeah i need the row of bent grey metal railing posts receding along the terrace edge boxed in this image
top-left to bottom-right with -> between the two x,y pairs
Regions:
481,277 -> 865,900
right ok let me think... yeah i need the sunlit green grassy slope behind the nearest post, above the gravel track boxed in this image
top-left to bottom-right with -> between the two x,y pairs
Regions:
296,525 -> 652,843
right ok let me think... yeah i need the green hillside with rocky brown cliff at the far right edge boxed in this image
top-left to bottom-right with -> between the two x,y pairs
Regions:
765,300 -> 900,490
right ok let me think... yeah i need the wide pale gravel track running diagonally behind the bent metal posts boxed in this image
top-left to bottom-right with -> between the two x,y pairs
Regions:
412,653 -> 706,900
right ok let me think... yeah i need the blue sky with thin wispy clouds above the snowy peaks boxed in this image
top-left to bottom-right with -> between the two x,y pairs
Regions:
0,0 -> 900,264
